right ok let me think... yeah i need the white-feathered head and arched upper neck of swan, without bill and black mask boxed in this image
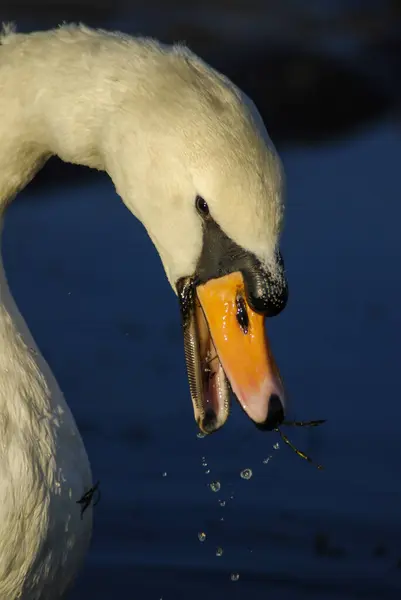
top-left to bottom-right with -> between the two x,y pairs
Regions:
0,26 -> 283,296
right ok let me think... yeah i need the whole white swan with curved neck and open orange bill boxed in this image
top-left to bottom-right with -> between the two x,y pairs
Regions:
0,26 -> 287,600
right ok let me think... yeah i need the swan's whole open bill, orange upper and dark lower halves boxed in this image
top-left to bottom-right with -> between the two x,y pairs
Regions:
180,272 -> 285,433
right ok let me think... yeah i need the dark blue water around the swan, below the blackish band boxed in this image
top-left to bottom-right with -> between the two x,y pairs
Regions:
4,124 -> 401,600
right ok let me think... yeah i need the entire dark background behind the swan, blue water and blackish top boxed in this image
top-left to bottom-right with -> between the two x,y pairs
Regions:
0,0 -> 401,600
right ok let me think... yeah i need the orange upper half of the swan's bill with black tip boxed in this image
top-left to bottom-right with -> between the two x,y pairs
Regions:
196,272 -> 285,429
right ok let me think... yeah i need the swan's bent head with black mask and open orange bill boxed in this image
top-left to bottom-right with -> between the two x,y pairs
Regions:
108,48 -> 288,433
